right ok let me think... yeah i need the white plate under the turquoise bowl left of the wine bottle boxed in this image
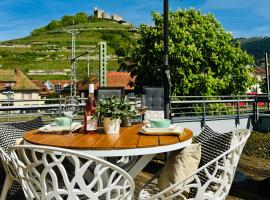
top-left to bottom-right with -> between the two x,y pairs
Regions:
38,122 -> 82,133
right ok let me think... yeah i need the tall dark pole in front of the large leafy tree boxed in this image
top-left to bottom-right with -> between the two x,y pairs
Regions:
162,0 -> 171,119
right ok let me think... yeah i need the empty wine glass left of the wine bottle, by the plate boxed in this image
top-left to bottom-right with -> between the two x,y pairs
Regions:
63,96 -> 79,134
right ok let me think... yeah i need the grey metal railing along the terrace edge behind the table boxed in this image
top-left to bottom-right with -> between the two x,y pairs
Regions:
0,96 -> 269,125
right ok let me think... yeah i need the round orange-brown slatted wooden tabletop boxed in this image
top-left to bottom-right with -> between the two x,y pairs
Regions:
24,124 -> 192,150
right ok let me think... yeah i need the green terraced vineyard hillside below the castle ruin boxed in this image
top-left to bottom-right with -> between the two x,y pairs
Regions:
0,19 -> 137,80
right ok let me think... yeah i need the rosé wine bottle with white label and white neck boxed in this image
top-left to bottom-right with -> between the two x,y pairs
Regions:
84,84 -> 97,133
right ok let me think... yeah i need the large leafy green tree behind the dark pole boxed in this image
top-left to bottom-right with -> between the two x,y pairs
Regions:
122,9 -> 254,95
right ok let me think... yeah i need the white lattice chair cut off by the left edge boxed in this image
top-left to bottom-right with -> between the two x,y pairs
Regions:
0,147 -> 20,200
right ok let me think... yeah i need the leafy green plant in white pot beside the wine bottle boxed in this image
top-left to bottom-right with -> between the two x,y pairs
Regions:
97,96 -> 122,134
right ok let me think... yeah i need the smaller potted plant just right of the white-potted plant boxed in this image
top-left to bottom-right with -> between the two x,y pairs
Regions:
121,98 -> 136,127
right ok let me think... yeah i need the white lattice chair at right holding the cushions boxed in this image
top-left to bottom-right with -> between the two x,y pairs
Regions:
139,129 -> 250,200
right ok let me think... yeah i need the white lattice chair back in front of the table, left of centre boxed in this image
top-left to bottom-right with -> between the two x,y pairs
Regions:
10,145 -> 135,200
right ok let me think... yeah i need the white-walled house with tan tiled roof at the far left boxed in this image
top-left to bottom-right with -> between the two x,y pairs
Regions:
0,69 -> 43,106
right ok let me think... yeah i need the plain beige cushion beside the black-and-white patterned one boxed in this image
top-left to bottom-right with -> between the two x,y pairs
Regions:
158,144 -> 201,190
